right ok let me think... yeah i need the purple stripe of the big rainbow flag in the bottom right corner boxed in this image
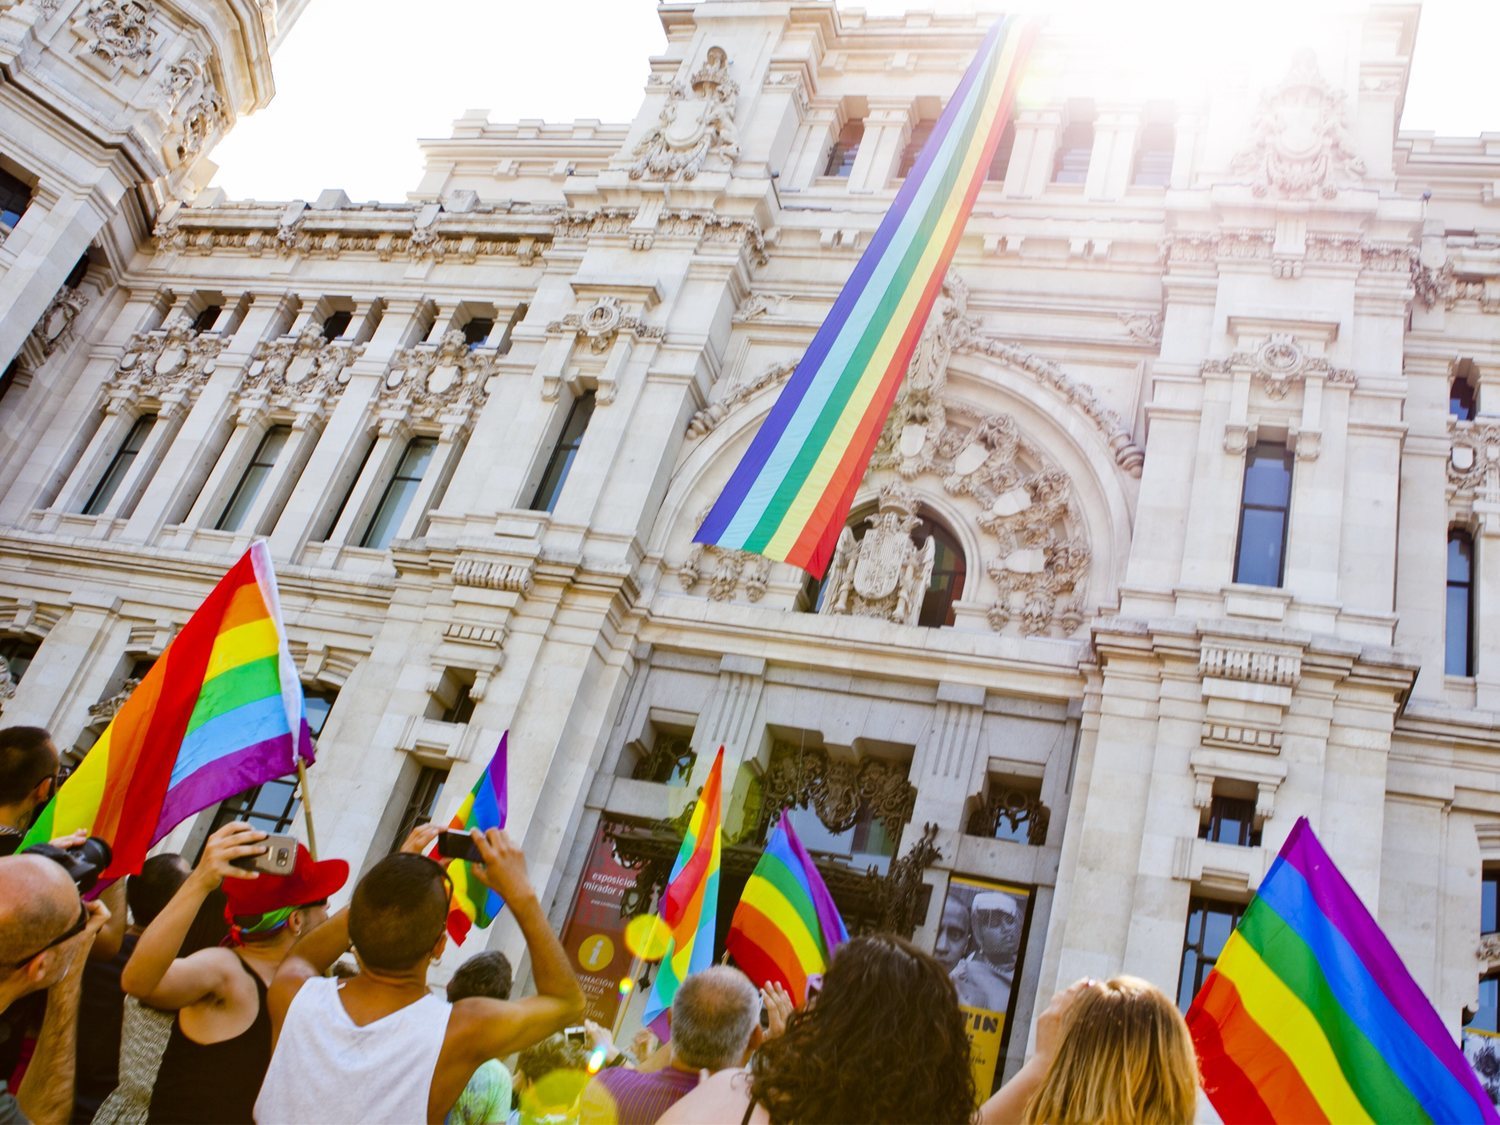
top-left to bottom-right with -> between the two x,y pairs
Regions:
1268,816 -> 1497,1121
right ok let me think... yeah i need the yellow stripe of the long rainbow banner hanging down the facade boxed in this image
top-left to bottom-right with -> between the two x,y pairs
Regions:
764,30 -> 1023,560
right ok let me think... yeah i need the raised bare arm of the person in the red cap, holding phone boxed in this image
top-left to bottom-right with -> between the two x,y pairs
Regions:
120,822 -> 266,1011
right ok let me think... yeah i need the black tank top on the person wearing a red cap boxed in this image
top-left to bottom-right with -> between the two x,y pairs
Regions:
147,957 -> 272,1125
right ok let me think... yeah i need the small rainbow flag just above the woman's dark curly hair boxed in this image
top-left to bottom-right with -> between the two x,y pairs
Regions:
725,812 -> 849,1008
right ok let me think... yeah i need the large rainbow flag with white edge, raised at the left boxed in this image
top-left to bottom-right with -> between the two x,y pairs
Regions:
21,542 -> 312,881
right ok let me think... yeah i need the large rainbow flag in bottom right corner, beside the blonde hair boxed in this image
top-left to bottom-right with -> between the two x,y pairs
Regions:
1188,818 -> 1497,1125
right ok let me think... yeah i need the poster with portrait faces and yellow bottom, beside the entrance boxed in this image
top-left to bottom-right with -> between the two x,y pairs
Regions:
933,876 -> 1031,1101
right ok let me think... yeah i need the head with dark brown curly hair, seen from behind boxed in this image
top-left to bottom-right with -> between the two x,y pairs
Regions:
750,935 -> 974,1122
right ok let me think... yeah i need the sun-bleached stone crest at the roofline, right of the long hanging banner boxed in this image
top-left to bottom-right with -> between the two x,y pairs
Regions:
1233,51 -> 1365,200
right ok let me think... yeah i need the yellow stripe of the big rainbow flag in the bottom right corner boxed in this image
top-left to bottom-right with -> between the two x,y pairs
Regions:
1217,933 -> 1370,1122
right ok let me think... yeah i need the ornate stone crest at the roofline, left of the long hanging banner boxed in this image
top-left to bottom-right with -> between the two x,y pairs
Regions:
630,47 -> 740,182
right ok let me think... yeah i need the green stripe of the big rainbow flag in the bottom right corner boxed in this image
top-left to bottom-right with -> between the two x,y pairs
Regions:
1239,899 -> 1430,1121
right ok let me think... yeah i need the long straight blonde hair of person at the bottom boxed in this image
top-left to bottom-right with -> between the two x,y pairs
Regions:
1022,977 -> 1199,1125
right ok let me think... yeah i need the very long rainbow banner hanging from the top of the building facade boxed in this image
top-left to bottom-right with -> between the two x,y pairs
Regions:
696,17 -> 1035,578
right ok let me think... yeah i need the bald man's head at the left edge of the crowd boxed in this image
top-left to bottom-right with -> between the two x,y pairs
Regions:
0,855 -> 87,1008
